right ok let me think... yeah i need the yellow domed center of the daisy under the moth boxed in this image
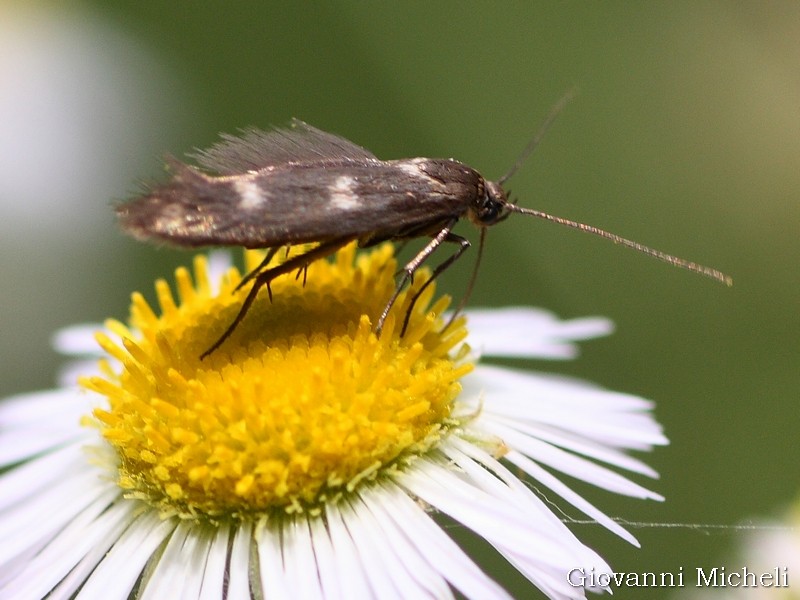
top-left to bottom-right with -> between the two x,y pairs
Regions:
82,245 -> 472,519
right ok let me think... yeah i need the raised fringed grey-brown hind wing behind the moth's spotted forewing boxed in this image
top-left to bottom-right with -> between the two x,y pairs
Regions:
193,119 -> 375,175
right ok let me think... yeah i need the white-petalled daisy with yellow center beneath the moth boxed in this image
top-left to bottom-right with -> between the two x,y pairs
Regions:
0,245 -> 666,599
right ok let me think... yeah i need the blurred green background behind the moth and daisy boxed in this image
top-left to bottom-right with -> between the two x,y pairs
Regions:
0,0 -> 800,598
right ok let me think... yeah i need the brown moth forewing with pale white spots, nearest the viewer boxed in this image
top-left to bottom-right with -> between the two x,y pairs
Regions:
117,160 -> 474,248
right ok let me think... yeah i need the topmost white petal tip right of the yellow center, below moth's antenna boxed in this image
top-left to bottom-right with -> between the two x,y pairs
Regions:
466,307 -> 614,359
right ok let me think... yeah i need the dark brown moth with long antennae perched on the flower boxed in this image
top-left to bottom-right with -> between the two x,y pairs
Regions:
116,96 -> 730,358
